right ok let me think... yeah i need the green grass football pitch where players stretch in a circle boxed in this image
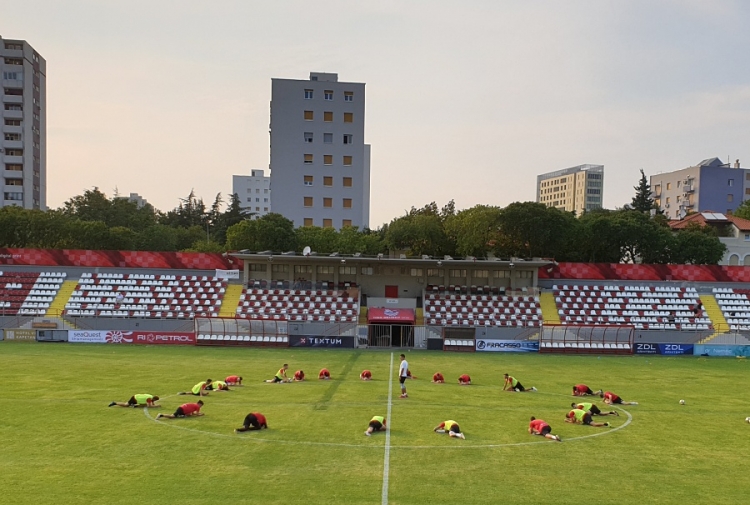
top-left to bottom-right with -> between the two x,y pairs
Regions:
0,342 -> 750,505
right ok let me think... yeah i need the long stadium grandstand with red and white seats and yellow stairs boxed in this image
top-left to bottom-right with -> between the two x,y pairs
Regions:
0,249 -> 750,354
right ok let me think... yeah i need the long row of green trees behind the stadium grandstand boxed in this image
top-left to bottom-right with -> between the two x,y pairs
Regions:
0,171 -> 732,264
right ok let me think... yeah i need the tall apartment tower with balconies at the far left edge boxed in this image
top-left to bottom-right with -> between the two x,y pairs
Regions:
0,37 -> 47,210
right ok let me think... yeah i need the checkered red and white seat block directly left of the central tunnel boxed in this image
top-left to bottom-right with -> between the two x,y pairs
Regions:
237,288 -> 359,323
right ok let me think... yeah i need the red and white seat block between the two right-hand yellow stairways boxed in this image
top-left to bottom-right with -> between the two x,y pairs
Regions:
552,285 -> 712,330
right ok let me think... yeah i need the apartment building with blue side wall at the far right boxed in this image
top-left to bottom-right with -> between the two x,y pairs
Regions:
649,158 -> 750,219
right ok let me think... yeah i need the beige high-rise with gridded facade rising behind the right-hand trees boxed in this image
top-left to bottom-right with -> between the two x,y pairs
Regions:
536,165 -> 604,216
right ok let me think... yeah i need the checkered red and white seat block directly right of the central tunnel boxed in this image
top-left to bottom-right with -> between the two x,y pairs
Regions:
424,292 -> 542,327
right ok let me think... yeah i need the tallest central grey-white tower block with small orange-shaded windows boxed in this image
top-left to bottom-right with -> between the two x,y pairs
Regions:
270,72 -> 370,229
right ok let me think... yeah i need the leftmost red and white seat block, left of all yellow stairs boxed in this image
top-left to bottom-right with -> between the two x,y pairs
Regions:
0,272 -> 67,316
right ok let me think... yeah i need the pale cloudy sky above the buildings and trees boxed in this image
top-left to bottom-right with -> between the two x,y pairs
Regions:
0,0 -> 750,224
